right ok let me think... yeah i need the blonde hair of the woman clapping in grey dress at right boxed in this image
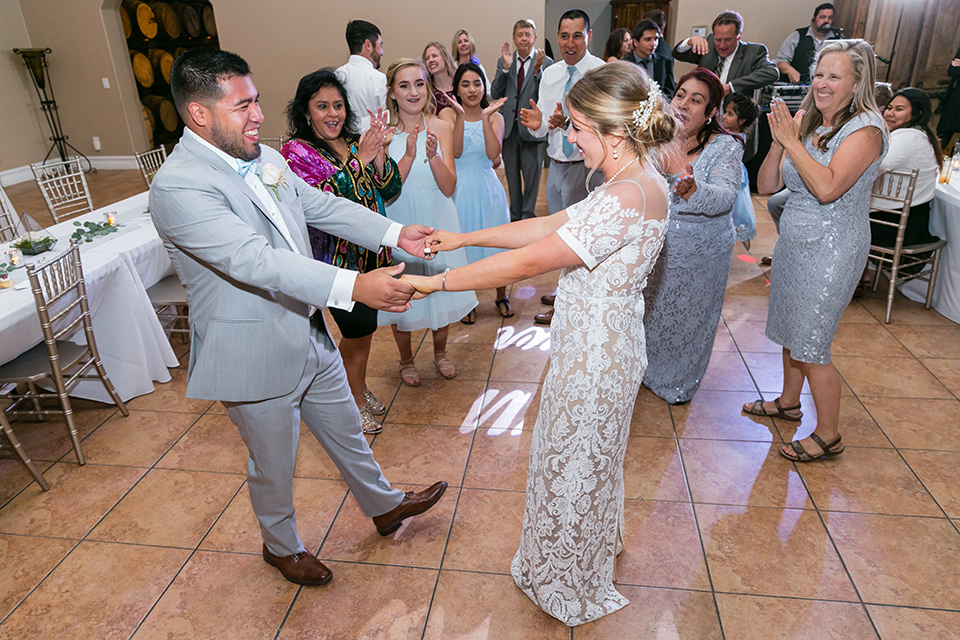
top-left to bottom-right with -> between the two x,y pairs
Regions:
799,39 -> 880,151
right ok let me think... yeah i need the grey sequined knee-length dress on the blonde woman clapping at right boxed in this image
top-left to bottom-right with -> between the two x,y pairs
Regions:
766,113 -> 887,364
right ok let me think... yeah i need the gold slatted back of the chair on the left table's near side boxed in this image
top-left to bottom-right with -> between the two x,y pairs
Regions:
27,239 -> 100,379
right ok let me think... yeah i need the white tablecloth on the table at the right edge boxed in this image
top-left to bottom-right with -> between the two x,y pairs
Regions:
900,178 -> 960,323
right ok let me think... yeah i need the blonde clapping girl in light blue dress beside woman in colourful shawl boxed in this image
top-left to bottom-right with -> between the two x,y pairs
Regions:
379,58 -> 477,387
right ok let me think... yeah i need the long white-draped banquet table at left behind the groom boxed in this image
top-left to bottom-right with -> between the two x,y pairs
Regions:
0,192 -> 178,402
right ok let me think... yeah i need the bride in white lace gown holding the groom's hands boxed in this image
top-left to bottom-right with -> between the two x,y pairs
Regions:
405,62 -> 676,626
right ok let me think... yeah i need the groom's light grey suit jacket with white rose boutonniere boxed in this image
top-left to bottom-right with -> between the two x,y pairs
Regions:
150,135 -> 390,402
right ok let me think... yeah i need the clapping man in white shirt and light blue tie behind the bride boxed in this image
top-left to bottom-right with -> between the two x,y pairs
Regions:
520,9 -> 604,324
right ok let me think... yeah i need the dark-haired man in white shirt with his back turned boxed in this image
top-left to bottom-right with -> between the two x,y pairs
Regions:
337,20 -> 387,133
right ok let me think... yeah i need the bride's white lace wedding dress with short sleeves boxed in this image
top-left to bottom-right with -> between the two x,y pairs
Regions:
510,175 -> 667,626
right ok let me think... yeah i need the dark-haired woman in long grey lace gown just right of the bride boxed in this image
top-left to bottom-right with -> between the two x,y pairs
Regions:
643,68 -> 743,404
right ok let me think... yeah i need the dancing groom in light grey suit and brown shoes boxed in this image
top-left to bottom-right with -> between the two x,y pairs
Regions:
150,49 -> 446,585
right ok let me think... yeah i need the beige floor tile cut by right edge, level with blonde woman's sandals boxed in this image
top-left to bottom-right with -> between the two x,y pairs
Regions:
863,398 -> 960,451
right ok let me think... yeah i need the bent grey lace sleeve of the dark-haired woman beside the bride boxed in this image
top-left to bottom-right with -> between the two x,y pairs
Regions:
671,134 -> 743,217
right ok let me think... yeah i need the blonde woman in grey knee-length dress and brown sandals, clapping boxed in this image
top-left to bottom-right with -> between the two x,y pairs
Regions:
743,40 -> 887,462
